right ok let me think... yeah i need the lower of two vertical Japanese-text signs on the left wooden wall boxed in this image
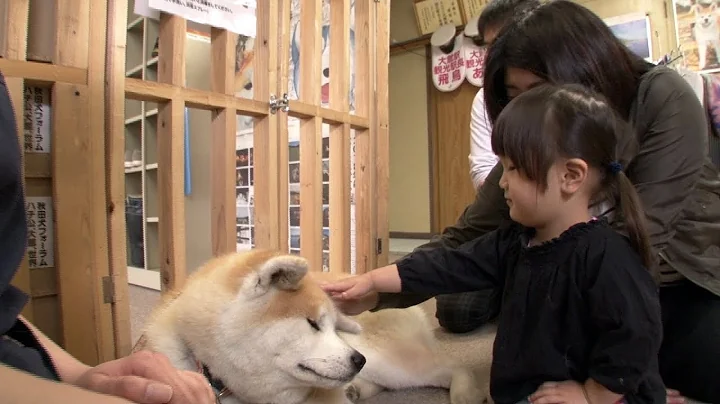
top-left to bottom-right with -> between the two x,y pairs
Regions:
25,196 -> 55,268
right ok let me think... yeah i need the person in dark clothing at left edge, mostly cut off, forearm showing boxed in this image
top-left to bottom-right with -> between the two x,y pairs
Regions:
0,72 -> 215,404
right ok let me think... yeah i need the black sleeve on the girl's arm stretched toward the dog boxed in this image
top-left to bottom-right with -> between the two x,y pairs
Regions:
396,223 -> 517,295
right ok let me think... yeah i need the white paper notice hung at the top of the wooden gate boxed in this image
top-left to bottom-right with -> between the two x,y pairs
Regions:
148,0 -> 256,38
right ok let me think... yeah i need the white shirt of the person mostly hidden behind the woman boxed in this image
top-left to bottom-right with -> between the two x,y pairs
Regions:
468,89 -> 498,189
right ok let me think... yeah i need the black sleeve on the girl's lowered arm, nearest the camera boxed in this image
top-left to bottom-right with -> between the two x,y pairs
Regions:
585,235 -> 662,394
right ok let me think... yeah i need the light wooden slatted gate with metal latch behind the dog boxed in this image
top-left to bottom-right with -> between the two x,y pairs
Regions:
106,0 -> 390,356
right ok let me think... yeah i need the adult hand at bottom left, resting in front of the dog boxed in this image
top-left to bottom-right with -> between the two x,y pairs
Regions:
75,351 -> 215,404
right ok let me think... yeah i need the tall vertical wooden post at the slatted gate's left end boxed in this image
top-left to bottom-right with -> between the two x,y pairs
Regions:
105,0 -> 132,358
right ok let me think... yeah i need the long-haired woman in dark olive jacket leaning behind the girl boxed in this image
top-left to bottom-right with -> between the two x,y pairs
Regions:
330,0 -> 720,403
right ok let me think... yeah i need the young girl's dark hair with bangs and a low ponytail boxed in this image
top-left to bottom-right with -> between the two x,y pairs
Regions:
491,84 -> 654,271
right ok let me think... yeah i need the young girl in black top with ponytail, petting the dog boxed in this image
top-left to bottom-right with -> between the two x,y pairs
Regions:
323,85 -> 666,404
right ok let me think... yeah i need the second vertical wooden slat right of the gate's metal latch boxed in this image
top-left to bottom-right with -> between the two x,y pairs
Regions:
329,0 -> 351,272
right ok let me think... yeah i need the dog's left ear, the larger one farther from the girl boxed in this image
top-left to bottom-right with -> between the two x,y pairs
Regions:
253,255 -> 308,294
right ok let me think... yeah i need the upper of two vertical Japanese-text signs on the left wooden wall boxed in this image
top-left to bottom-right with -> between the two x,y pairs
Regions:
23,87 -> 50,153
